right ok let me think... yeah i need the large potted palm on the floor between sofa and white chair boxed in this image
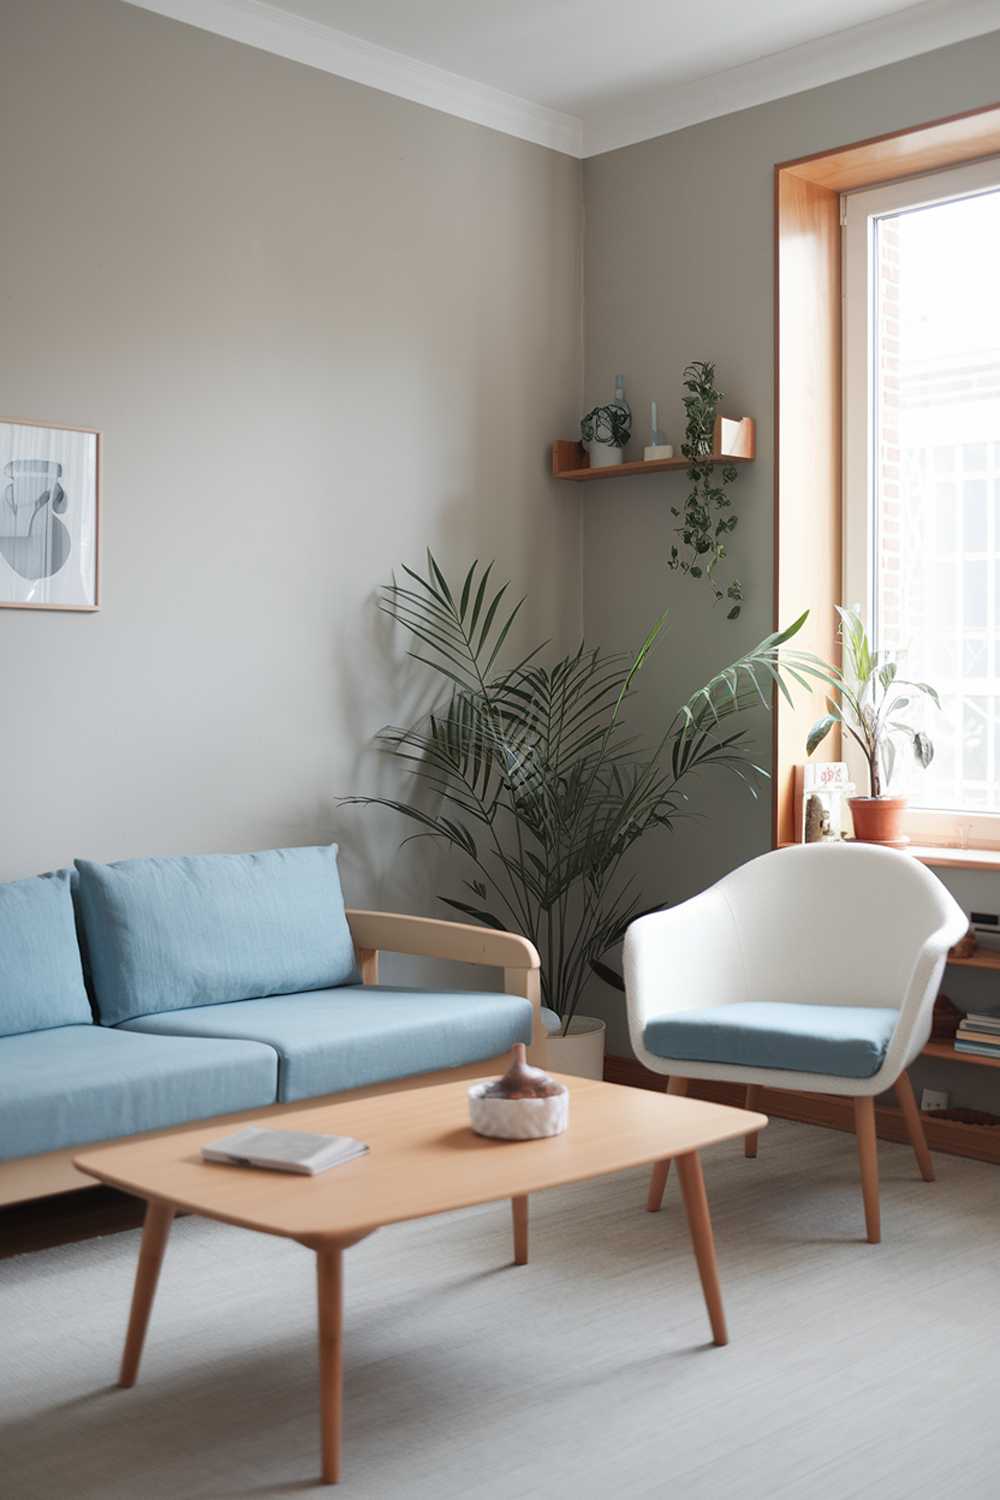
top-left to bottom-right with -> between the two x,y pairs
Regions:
345,554 -> 825,1076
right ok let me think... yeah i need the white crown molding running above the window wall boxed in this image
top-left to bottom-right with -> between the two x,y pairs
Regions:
580,0 -> 1000,158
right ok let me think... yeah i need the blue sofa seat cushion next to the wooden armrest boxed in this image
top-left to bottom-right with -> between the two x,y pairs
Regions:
119,984 -> 531,1101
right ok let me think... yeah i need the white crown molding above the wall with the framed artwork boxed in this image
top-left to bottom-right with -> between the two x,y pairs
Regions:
126,0 -> 583,156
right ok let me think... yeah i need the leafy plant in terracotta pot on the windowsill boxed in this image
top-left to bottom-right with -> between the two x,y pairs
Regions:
805,606 -> 942,849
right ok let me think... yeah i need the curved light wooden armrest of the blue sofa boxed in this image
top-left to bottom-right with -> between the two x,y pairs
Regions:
348,908 -> 546,1061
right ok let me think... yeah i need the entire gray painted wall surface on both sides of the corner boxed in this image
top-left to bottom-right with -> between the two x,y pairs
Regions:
0,0 -> 1000,1104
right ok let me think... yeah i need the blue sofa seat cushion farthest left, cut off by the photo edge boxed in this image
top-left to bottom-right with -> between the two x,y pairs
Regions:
0,1025 -> 277,1161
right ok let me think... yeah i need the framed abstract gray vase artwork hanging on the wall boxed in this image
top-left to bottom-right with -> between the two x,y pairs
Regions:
0,422 -> 100,609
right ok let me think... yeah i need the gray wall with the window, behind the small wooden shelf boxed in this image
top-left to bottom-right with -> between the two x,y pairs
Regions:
582,32 -> 1000,1074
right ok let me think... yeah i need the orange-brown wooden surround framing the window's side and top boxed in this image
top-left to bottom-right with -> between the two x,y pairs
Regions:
772,104 -> 1000,848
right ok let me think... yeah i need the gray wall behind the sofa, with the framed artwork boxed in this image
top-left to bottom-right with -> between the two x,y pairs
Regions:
0,0 -> 582,936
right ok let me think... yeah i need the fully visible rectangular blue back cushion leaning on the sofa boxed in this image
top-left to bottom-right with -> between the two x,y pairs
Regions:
76,845 -> 357,1026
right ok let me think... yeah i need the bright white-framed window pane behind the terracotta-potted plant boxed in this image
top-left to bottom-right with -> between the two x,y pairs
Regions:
843,159 -> 1000,848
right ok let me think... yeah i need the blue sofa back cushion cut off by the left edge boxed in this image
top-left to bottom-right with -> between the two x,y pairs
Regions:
0,870 -> 93,1037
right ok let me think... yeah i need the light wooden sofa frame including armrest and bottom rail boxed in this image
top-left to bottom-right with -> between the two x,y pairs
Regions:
0,909 -> 546,1206
